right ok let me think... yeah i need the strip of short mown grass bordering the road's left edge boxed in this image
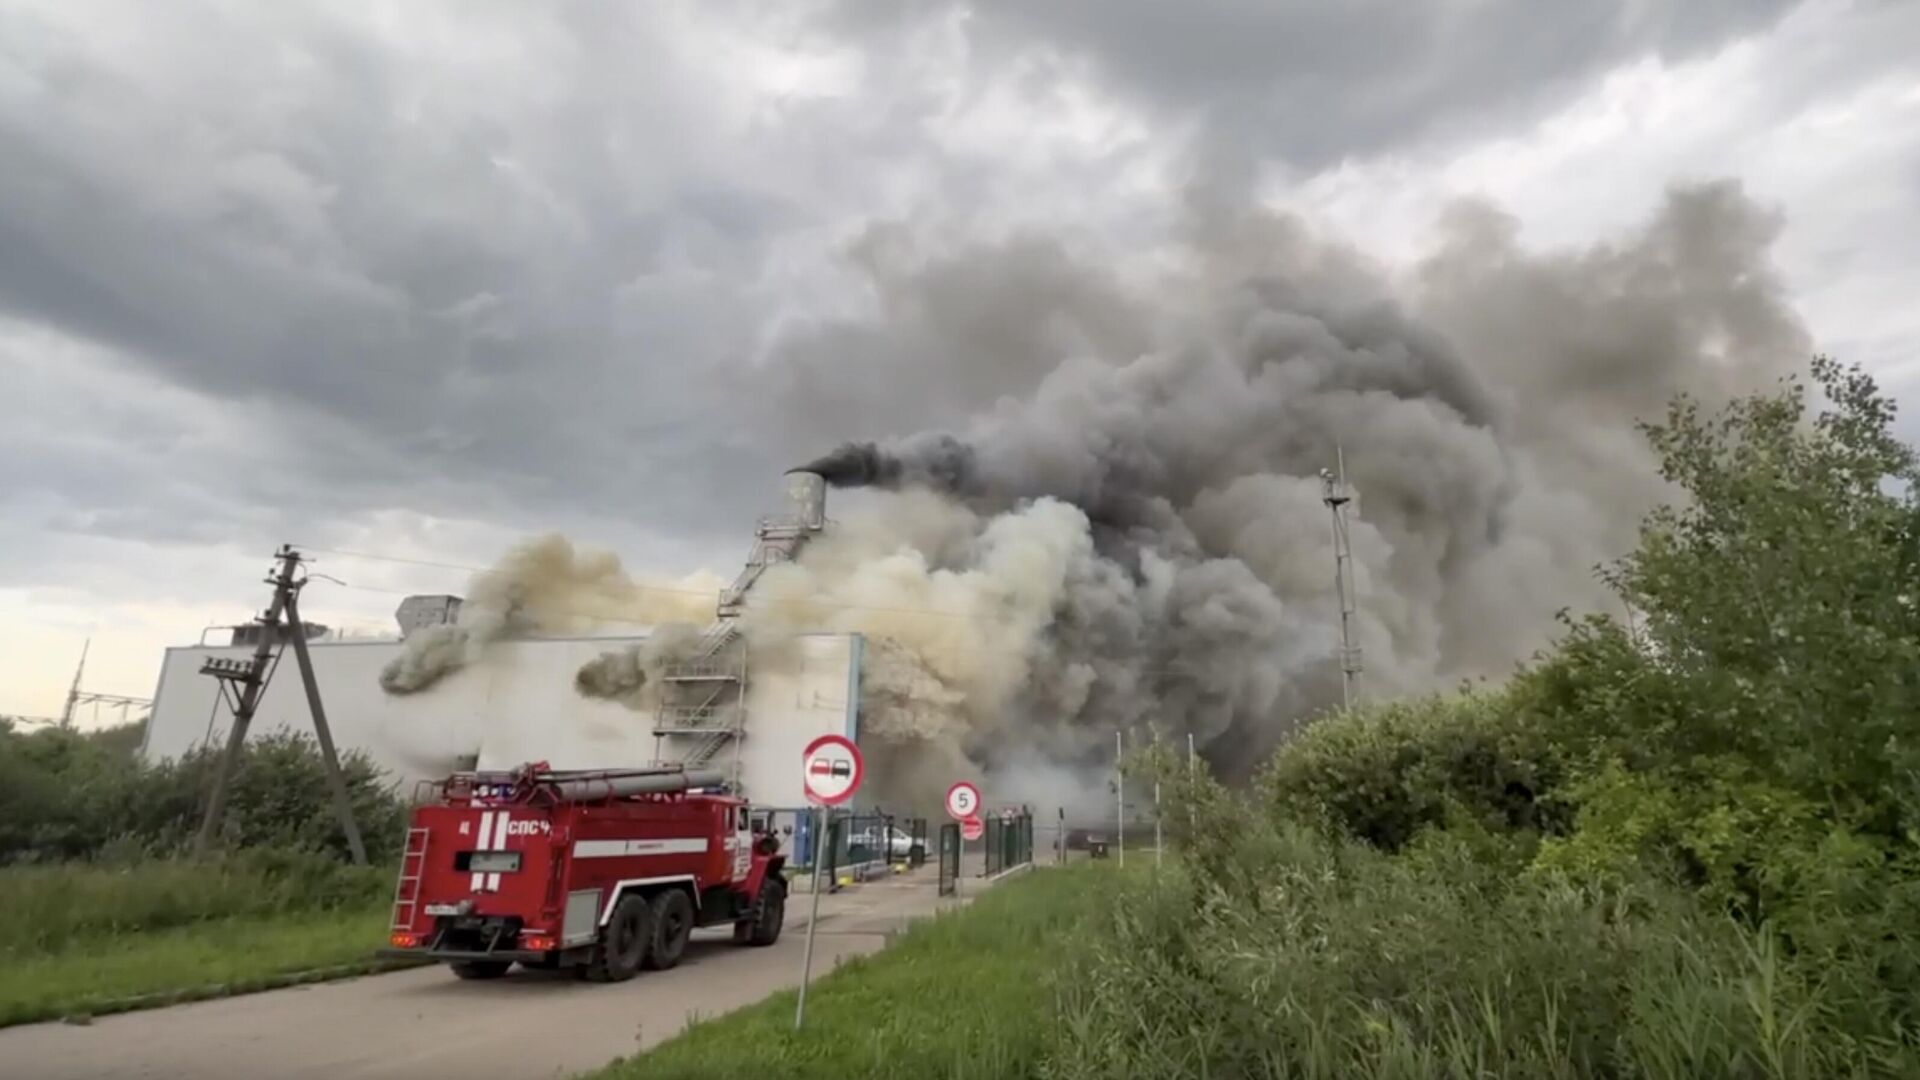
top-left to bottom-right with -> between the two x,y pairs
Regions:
0,905 -> 405,1026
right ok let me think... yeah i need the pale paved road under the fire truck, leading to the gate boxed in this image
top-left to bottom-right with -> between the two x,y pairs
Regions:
0,865 -> 981,1080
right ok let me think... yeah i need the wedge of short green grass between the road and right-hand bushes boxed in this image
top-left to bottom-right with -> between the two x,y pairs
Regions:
595,863 -> 1117,1080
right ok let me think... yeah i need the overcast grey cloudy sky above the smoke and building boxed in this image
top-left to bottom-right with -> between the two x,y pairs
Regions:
0,0 -> 1920,715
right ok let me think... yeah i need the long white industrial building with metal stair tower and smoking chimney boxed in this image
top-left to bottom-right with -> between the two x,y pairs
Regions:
142,473 -> 864,805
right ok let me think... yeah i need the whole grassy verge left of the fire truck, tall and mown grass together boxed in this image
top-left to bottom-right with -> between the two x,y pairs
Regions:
0,851 -> 392,1026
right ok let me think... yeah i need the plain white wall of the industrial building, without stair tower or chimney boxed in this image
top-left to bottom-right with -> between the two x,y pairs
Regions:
144,634 -> 860,805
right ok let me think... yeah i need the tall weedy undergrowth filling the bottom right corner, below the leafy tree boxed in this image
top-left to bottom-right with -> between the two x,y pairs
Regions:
1048,805 -> 1920,1078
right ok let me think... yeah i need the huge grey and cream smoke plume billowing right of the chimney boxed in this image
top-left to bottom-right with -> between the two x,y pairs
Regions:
753,184 -> 1809,773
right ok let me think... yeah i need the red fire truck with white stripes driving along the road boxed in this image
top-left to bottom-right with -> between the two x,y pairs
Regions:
382,763 -> 787,982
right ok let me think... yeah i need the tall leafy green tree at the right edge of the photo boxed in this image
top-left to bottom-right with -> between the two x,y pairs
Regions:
1524,357 -> 1920,915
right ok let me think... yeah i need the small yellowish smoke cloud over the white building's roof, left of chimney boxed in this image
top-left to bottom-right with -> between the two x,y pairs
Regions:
380,534 -> 720,698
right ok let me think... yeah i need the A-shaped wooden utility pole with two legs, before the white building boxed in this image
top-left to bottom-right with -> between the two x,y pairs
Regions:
194,544 -> 367,867
